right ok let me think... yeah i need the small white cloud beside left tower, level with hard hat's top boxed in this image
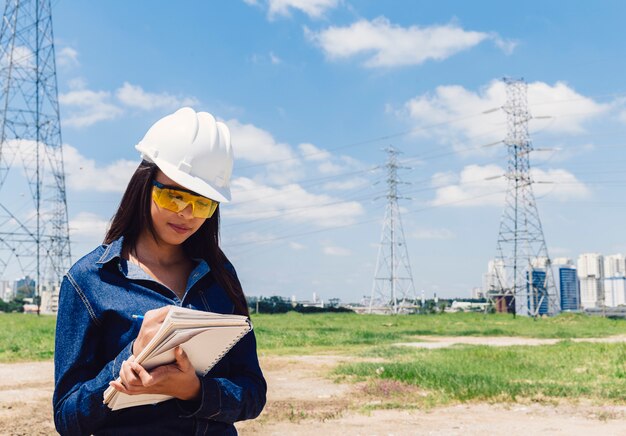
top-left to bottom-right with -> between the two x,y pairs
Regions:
59,89 -> 123,127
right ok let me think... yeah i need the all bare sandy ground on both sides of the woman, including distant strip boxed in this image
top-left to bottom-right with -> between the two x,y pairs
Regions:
0,336 -> 626,436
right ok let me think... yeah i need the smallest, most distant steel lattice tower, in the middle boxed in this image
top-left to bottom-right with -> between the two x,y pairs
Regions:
369,147 -> 417,314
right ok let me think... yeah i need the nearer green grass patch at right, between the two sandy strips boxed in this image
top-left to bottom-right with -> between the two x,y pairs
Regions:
335,340 -> 626,407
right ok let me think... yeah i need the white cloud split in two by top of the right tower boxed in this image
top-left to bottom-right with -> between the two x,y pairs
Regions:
401,80 -> 610,150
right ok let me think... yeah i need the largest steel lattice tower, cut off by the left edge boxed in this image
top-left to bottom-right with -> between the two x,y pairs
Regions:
0,0 -> 71,309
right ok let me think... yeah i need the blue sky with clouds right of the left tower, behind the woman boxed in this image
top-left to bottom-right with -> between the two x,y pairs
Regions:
12,0 -> 626,302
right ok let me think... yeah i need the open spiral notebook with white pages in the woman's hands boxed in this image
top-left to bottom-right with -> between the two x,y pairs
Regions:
104,306 -> 252,410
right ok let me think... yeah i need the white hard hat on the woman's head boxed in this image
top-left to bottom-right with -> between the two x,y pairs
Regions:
135,107 -> 233,202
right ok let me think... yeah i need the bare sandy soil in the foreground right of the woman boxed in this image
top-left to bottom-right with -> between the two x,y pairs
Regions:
237,352 -> 626,436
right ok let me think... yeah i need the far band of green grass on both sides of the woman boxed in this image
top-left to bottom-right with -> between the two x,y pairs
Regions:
0,312 -> 626,362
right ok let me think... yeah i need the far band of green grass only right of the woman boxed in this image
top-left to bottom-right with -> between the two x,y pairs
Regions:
252,312 -> 626,354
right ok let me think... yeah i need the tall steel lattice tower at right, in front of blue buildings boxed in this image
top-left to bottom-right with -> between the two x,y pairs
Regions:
489,79 -> 560,316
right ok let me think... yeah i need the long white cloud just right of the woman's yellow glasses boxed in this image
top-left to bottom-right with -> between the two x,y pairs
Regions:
224,177 -> 364,227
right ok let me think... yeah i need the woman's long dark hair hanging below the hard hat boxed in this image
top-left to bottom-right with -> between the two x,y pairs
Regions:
104,160 -> 249,316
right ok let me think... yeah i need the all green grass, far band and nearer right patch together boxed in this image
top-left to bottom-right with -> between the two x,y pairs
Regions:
0,312 -> 626,407
